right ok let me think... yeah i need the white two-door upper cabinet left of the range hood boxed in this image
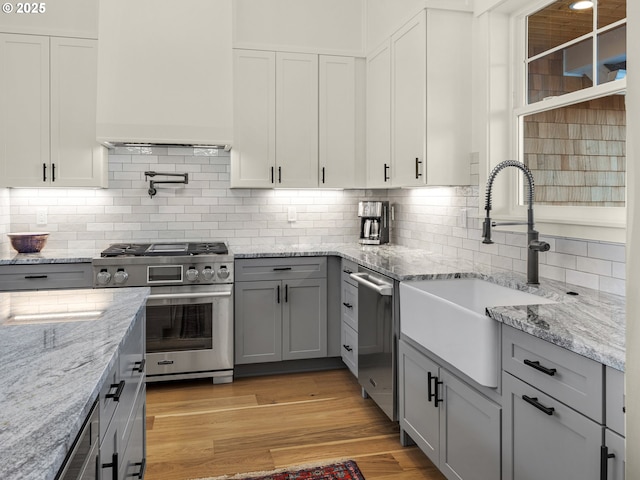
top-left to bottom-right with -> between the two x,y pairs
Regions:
0,34 -> 107,187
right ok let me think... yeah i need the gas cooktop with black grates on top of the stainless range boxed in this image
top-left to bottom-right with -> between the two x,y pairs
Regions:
100,242 -> 229,257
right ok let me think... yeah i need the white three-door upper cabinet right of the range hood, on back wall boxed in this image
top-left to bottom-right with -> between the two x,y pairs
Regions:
231,49 -> 364,188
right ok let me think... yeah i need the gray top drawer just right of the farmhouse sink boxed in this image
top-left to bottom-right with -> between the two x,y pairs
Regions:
502,326 -> 604,423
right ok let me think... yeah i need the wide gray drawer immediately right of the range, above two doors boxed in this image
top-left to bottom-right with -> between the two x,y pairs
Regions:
235,257 -> 327,282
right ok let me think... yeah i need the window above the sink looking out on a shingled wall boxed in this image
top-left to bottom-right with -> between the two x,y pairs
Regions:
512,0 -> 626,238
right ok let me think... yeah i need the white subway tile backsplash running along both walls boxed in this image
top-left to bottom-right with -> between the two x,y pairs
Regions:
0,147 -> 625,294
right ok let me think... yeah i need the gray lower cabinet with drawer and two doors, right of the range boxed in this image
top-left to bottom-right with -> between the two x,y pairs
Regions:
235,257 -> 327,364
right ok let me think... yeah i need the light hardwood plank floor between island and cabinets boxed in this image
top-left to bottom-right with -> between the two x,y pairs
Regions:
145,369 -> 444,480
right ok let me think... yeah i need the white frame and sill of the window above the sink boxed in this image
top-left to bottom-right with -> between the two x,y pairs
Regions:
480,0 -> 627,243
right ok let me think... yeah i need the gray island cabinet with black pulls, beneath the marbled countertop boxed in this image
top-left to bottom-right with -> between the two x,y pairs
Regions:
98,313 -> 146,480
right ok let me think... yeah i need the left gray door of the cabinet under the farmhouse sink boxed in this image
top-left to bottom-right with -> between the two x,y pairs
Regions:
398,341 -> 442,466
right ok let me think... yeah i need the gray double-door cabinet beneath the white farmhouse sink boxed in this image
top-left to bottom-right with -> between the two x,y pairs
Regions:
399,340 -> 501,480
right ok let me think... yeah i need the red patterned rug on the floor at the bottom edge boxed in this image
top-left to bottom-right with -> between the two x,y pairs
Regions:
192,460 -> 365,480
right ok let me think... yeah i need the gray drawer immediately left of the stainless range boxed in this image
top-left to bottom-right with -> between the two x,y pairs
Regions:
0,263 -> 93,291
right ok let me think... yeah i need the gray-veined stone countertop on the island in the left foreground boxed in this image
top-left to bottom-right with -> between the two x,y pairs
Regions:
0,287 -> 149,480
